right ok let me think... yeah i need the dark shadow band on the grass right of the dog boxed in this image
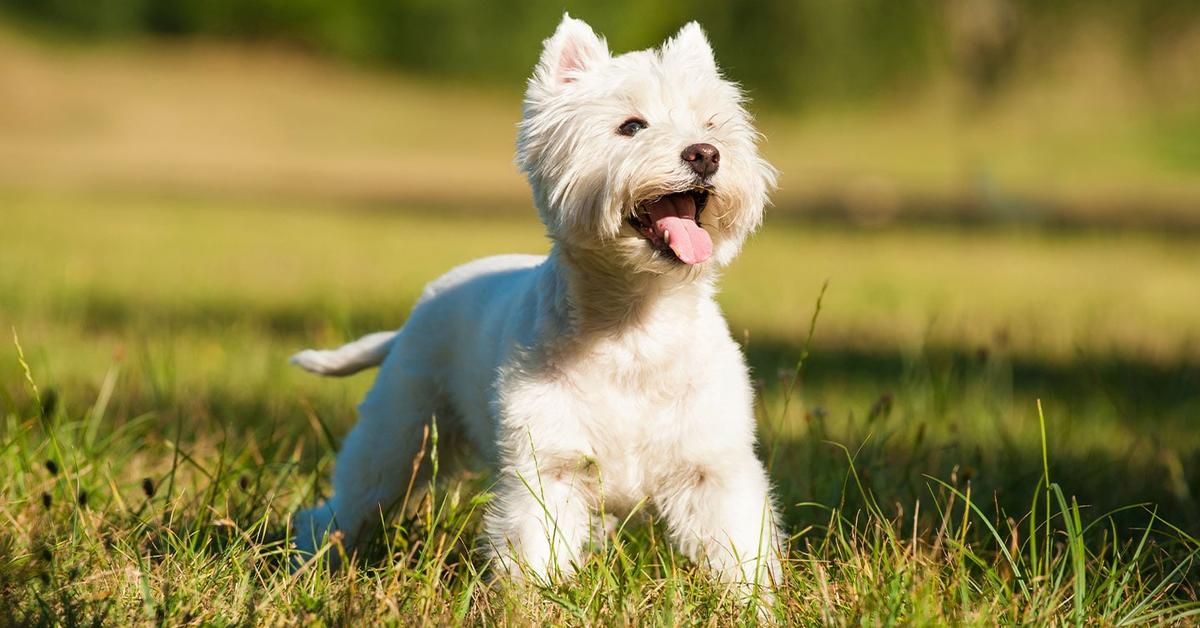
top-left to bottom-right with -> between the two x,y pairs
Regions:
746,340 -> 1200,534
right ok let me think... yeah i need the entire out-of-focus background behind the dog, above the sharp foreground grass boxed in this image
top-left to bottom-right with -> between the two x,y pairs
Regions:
0,0 -> 1200,528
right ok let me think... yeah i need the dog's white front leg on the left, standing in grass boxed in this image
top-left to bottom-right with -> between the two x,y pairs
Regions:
485,459 -> 600,582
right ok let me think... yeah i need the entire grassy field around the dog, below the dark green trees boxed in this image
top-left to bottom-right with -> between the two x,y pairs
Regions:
0,15 -> 1200,626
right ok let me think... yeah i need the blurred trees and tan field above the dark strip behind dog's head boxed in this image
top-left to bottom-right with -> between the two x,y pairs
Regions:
0,0 -> 1200,223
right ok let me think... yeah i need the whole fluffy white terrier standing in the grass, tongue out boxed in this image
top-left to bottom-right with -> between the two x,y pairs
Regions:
293,16 -> 781,595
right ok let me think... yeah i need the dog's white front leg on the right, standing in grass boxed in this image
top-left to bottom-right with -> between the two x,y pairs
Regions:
654,451 -> 781,600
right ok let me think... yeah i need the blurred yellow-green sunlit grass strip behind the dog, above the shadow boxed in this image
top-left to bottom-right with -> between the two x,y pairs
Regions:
0,191 -> 1200,361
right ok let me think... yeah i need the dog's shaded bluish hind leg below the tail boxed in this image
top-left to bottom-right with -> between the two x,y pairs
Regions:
294,355 -> 437,566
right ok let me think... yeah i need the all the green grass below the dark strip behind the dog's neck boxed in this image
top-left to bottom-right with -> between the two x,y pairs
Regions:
0,189 -> 1200,624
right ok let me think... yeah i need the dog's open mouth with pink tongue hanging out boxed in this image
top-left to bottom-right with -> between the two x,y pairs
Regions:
629,187 -> 713,264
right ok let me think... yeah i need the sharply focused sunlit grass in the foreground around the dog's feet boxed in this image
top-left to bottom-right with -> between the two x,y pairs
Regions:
0,304 -> 1200,624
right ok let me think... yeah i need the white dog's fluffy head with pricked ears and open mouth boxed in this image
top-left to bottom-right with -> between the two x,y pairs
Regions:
517,16 -> 775,274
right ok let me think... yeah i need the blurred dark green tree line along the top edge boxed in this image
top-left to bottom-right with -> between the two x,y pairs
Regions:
0,0 -> 1200,107
